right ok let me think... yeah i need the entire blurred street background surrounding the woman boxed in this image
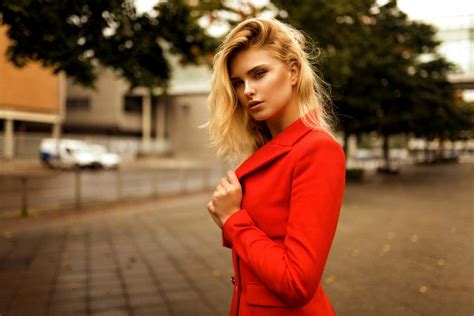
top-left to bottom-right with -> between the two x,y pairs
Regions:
0,0 -> 474,315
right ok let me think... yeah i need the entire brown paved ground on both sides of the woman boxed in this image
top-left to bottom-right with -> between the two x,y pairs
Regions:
0,163 -> 474,316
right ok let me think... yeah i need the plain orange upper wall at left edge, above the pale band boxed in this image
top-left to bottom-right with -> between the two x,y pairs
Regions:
0,27 -> 60,113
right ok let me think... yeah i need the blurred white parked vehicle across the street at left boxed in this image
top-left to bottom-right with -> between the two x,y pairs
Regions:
39,138 -> 120,169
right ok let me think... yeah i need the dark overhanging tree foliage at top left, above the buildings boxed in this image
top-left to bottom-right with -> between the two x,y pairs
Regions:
0,0 -> 216,88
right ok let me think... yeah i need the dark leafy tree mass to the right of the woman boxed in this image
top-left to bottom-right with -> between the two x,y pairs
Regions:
273,0 -> 472,169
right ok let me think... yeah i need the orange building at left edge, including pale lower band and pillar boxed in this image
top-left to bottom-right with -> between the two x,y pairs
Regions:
0,27 -> 66,159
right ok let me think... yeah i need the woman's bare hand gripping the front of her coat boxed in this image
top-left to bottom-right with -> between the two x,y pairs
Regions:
207,170 -> 242,229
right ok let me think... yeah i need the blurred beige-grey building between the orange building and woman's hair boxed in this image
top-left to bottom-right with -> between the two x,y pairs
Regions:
64,59 -> 212,157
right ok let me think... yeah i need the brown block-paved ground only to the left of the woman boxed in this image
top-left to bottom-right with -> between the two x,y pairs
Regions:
0,194 -> 232,316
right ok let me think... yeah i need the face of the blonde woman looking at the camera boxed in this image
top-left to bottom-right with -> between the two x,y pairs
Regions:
229,47 -> 298,124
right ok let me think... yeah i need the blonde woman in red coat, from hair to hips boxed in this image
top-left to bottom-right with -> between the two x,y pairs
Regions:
207,19 -> 345,316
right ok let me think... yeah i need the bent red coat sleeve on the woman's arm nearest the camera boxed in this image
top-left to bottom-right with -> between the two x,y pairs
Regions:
223,139 -> 345,307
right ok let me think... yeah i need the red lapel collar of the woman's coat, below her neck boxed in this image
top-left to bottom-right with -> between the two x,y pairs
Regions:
235,118 -> 311,180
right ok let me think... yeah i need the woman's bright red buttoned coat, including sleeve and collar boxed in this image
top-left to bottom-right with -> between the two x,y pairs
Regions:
223,119 -> 345,316
